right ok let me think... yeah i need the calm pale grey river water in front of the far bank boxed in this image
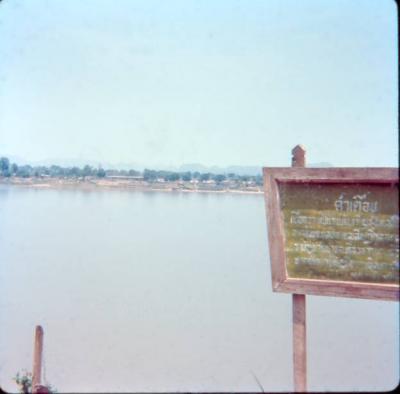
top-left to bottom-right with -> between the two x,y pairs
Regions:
0,186 -> 399,392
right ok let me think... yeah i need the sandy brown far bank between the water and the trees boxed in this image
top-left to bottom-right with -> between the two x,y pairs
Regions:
0,177 -> 263,194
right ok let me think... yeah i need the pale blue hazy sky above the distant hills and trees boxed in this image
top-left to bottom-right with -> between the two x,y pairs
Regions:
0,0 -> 398,167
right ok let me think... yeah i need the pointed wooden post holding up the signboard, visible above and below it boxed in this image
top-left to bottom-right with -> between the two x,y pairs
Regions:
292,145 -> 307,392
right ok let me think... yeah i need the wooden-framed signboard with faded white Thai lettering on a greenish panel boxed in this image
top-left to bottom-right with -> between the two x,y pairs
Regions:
263,167 -> 399,300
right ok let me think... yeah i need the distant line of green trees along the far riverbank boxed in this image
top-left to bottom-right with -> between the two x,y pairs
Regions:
0,157 -> 263,186
